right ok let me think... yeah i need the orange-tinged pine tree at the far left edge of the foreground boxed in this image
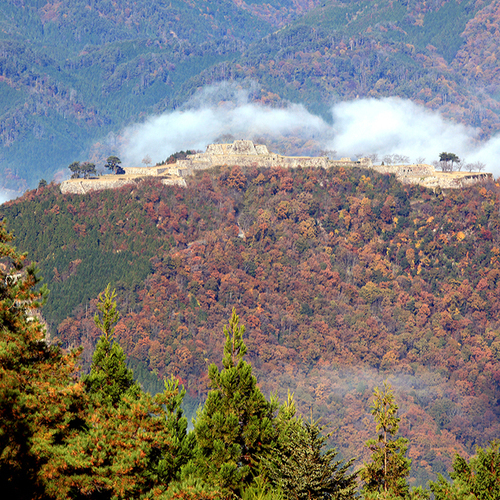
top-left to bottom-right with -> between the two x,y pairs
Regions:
0,222 -> 86,499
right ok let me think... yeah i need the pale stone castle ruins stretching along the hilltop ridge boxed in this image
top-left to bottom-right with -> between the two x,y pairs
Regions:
61,140 -> 492,194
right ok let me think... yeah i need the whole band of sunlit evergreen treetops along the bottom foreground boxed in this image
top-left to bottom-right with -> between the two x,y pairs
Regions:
0,218 -> 500,500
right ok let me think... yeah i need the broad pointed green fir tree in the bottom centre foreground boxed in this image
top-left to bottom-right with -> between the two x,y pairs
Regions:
194,309 -> 277,496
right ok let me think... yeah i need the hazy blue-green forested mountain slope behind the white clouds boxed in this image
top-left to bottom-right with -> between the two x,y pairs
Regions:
0,0 -> 500,192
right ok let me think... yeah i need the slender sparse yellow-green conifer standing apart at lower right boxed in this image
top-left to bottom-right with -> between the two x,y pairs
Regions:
360,381 -> 411,499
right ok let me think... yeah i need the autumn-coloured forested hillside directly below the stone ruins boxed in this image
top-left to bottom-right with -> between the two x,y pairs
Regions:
0,167 -> 500,484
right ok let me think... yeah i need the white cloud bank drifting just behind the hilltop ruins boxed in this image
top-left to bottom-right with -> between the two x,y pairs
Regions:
120,85 -> 500,175
